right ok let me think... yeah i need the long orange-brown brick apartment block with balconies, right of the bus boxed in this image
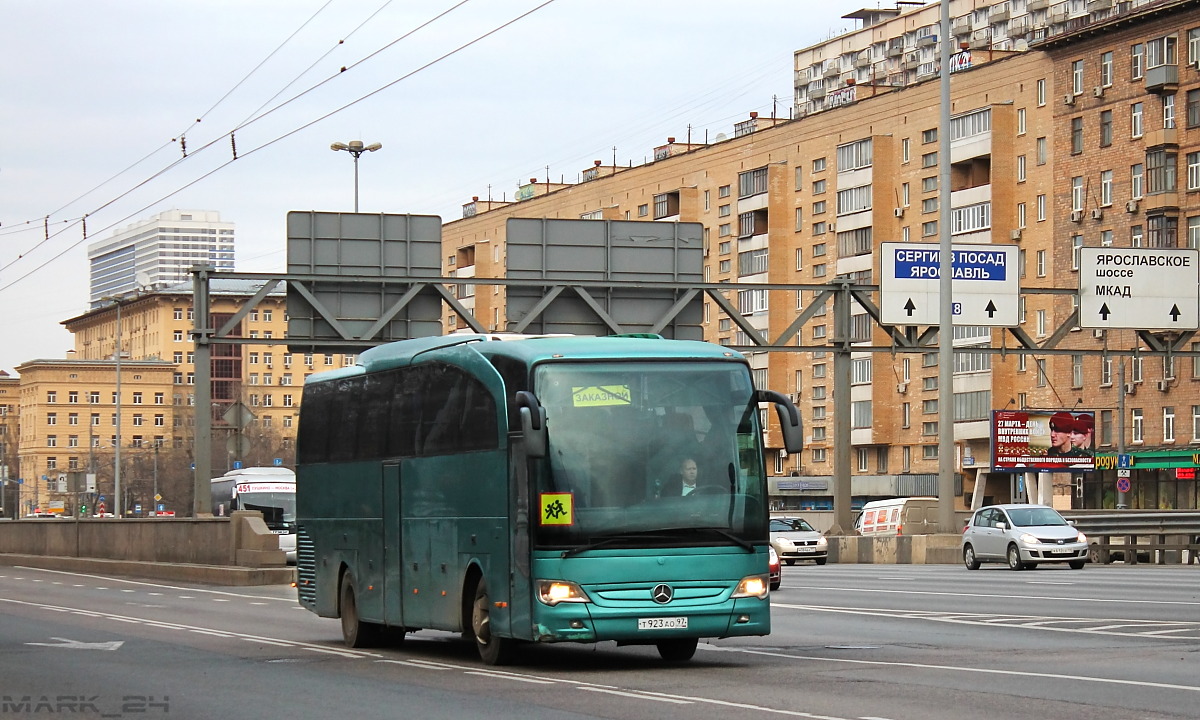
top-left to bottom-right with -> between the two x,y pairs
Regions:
443,0 -> 1200,518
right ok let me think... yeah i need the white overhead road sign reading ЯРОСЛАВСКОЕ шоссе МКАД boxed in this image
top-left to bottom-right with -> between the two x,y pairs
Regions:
1079,247 -> 1200,330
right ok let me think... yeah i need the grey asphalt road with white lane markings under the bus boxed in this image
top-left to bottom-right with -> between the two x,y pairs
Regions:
0,565 -> 1200,720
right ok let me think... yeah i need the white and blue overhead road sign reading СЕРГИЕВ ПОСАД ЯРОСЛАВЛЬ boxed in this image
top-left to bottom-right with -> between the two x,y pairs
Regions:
880,242 -> 1020,328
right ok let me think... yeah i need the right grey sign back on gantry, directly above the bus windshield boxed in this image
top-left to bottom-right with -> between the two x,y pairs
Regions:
505,218 -> 704,340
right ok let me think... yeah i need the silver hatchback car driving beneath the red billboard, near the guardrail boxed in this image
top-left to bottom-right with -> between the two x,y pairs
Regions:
962,505 -> 1087,570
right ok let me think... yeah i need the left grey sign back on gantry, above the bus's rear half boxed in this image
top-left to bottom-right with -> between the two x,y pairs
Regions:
287,211 -> 442,350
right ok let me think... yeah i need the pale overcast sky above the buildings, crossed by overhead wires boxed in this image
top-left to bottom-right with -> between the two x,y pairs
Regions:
0,0 -> 873,372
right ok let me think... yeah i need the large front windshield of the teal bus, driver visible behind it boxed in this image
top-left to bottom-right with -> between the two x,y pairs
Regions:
533,361 -> 767,548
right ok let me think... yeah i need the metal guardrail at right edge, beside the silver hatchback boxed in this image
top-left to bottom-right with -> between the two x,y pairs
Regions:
1063,510 -> 1200,565
